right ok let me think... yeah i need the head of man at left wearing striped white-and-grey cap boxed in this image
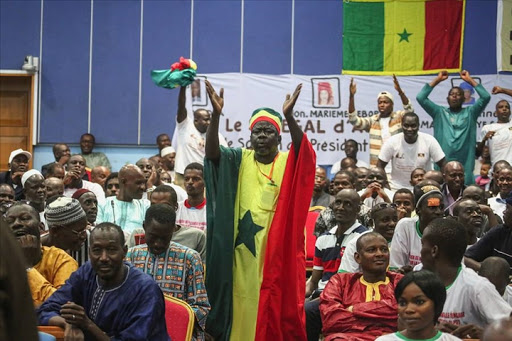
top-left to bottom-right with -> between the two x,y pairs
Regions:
42,197 -> 87,252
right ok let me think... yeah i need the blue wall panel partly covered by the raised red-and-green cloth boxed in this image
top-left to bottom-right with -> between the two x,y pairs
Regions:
140,0 -> 190,144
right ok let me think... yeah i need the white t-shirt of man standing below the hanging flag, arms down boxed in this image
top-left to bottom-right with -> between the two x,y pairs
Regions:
379,132 -> 445,190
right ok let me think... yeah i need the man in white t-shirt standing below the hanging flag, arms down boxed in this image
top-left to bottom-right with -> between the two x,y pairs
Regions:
377,112 -> 445,191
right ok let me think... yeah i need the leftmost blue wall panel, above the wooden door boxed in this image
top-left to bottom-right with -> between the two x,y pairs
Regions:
0,0 -> 41,70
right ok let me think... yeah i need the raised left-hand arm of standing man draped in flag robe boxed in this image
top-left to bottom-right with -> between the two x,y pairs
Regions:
204,80 -> 224,161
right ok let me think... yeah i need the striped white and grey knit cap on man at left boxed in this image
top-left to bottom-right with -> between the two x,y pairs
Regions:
44,197 -> 85,227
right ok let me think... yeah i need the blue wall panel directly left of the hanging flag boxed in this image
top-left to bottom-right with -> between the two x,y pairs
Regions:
293,1 -> 343,75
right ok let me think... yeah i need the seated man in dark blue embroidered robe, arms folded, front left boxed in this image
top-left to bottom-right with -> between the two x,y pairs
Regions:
37,223 -> 169,341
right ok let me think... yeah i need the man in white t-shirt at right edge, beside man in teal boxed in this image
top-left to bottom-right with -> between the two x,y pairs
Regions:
477,87 -> 512,165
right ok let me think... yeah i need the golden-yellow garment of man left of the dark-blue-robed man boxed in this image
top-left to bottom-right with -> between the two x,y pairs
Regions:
27,246 -> 78,307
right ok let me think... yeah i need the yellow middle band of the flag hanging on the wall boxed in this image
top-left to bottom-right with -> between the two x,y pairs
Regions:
383,1 -> 425,70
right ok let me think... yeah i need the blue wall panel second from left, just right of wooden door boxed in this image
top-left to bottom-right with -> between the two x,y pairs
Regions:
40,1 -> 91,143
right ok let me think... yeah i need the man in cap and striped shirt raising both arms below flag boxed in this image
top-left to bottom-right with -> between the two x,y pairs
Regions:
348,75 -> 413,167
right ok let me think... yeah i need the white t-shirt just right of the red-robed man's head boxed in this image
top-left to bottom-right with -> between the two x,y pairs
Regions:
389,217 -> 421,269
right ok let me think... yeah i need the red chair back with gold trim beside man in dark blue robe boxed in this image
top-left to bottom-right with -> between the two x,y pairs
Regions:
164,294 -> 195,341
